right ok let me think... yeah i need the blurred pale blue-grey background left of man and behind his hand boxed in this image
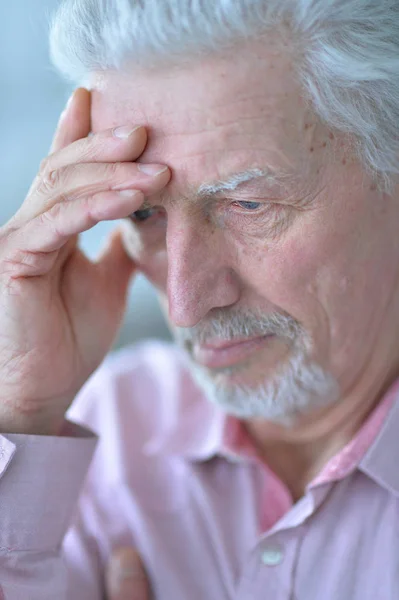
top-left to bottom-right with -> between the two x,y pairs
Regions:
0,0 -> 169,347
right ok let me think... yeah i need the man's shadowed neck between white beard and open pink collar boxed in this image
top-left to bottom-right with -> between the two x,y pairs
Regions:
244,358 -> 399,501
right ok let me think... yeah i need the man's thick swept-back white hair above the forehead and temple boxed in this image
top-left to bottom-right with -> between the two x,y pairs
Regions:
50,0 -> 399,193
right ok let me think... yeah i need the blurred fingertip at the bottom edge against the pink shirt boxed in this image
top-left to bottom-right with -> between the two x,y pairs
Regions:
106,548 -> 151,600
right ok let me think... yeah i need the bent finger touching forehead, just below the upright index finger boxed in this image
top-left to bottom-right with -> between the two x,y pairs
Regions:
42,124 -> 148,170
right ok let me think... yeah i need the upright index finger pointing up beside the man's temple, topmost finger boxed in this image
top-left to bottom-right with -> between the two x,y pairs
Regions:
50,88 -> 91,153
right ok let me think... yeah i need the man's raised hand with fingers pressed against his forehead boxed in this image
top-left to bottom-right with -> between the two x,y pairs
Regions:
0,88 -> 170,435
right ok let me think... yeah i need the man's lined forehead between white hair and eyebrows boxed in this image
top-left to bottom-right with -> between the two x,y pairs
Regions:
91,37 -> 314,184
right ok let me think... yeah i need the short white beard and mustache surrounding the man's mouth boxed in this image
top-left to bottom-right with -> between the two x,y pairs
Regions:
174,309 -> 340,427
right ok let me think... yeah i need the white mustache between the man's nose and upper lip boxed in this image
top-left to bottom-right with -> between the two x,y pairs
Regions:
174,309 -> 303,346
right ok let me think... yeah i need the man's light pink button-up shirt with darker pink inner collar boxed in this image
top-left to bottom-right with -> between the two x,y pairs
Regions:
0,342 -> 399,600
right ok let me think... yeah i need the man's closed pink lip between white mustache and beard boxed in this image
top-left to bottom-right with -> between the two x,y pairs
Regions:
193,335 -> 274,369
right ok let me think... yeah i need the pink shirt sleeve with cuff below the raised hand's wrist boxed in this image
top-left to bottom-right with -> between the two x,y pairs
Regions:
0,424 -> 104,600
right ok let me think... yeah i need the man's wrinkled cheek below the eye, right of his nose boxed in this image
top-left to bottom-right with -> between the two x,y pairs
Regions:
240,224 -> 381,364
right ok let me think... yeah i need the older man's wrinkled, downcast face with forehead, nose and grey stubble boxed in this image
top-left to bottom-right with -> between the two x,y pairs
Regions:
92,38 -> 399,420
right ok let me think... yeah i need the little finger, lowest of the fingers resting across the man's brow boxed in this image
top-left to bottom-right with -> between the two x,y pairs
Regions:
3,190 -> 144,278
